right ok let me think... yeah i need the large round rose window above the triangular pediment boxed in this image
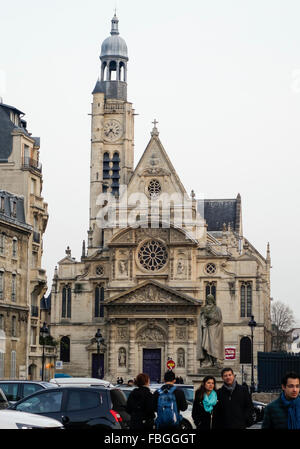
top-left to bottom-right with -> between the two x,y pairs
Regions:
138,240 -> 168,271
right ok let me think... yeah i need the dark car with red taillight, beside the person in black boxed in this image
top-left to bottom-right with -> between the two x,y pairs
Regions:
10,385 -> 130,429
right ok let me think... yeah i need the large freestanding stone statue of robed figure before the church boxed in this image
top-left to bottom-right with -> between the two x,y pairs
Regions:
197,295 -> 224,368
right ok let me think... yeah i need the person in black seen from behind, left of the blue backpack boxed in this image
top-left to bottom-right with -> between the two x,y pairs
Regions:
126,373 -> 155,430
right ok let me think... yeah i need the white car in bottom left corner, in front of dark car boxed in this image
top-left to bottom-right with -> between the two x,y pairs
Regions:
0,409 -> 64,429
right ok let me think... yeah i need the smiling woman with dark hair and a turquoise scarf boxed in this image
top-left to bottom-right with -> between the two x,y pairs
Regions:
192,376 -> 218,430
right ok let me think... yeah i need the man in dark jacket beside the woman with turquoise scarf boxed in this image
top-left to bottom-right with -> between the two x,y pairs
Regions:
217,368 -> 254,429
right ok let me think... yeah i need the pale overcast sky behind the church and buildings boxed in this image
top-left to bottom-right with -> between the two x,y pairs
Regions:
0,0 -> 300,321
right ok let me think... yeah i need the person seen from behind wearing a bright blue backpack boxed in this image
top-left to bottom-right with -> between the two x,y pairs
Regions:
153,371 -> 188,430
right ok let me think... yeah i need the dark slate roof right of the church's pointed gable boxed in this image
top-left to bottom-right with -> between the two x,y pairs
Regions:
197,195 -> 241,233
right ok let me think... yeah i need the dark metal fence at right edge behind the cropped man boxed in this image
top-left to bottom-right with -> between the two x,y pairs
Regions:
257,352 -> 300,392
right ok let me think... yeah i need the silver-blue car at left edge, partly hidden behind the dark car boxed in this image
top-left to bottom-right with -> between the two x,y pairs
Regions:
0,380 -> 55,405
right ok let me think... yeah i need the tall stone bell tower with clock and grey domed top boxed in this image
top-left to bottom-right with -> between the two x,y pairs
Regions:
88,14 -> 134,254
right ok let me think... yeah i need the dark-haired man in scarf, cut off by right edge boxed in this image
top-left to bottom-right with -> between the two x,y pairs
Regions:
262,372 -> 300,429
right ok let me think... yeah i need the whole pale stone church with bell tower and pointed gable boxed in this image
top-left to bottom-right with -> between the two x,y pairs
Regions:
51,16 -> 271,382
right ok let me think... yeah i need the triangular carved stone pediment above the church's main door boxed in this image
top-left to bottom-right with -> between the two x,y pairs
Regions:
106,281 -> 202,306
